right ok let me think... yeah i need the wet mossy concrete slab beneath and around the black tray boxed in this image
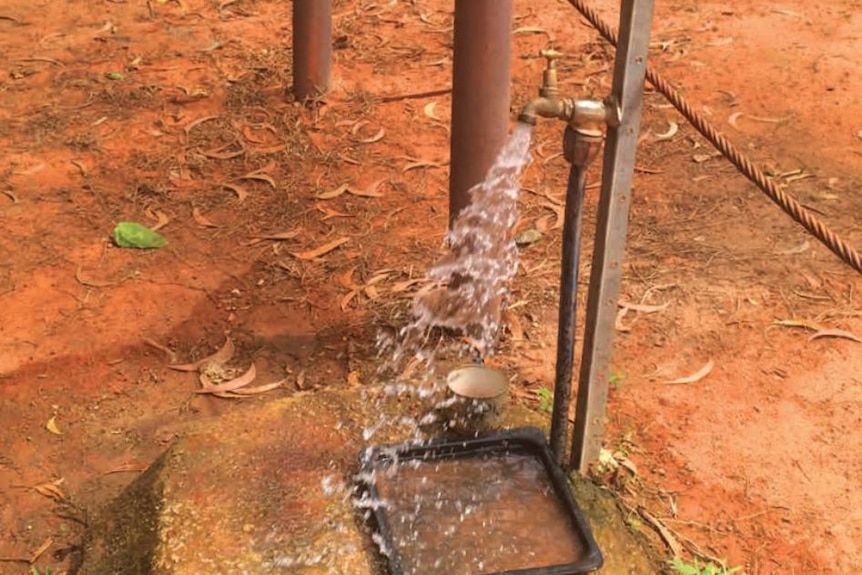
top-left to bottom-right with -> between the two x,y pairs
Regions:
79,391 -> 656,575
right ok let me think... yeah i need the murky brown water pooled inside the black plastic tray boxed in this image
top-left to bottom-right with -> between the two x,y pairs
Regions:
376,454 -> 584,575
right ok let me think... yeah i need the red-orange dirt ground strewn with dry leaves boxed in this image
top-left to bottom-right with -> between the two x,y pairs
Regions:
0,0 -> 862,574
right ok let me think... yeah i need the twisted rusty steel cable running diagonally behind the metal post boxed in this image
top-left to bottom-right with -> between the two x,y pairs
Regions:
568,0 -> 862,273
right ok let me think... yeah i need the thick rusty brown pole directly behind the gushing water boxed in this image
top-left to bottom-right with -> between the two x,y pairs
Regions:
449,0 -> 513,225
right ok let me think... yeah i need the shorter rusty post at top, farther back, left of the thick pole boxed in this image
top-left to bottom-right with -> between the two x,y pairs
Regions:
293,0 -> 332,101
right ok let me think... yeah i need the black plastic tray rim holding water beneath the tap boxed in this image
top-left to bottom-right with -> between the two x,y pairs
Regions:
359,427 -> 604,575
